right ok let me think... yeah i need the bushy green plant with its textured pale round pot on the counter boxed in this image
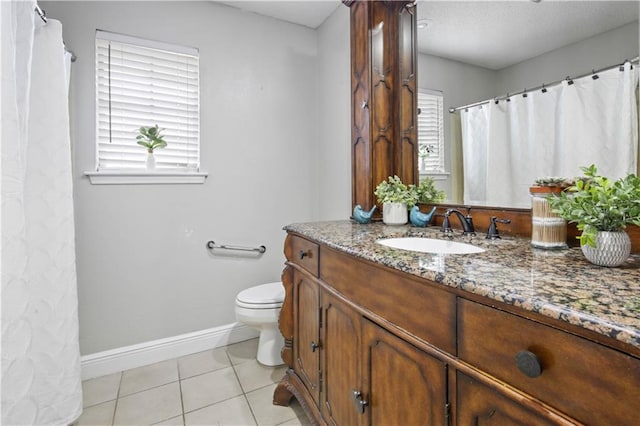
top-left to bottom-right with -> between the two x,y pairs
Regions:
549,165 -> 640,266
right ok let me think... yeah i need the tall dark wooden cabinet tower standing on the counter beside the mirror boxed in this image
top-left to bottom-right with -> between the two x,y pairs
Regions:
343,0 -> 418,210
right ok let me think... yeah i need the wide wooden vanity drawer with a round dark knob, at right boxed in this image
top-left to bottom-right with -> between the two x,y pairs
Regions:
458,299 -> 640,425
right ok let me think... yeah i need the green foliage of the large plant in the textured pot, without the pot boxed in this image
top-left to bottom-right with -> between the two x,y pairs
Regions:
549,165 -> 640,247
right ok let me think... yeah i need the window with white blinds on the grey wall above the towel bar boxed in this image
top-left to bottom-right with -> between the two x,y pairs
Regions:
96,31 -> 200,172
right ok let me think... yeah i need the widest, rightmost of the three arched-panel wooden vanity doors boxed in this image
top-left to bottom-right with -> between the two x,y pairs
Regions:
363,319 -> 447,426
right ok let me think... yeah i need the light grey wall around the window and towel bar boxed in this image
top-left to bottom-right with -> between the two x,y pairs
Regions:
46,1 -> 319,355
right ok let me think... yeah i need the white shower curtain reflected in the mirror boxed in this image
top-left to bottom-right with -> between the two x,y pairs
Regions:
461,62 -> 638,208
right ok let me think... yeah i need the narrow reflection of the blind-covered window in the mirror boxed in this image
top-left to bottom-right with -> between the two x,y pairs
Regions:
418,90 -> 445,173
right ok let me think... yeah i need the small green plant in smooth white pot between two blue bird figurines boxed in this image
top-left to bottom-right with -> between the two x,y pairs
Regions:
374,176 -> 418,225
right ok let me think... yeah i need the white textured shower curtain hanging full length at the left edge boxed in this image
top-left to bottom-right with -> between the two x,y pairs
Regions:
0,1 -> 82,425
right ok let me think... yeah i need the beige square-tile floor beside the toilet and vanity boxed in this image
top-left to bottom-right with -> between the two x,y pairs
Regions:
77,339 -> 309,426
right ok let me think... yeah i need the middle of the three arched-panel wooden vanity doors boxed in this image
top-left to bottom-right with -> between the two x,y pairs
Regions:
321,292 -> 362,426
